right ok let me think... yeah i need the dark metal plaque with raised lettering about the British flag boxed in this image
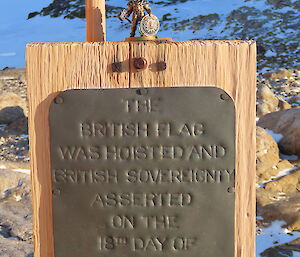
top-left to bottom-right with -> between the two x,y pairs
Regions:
50,87 -> 235,257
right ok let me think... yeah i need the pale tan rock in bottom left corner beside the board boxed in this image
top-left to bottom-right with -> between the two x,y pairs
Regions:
0,170 -> 33,257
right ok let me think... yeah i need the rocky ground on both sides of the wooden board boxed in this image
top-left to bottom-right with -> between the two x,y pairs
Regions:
0,69 -> 300,257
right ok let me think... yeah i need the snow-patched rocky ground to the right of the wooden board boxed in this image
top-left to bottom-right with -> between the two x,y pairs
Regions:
256,70 -> 300,257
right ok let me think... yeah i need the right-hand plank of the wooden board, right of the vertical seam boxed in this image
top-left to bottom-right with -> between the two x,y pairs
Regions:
130,41 -> 256,257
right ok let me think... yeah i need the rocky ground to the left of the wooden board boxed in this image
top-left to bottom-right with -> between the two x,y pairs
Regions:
0,69 -> 33,257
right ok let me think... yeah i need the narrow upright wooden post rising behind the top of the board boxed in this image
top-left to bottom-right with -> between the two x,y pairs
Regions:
86,0 -> 106,42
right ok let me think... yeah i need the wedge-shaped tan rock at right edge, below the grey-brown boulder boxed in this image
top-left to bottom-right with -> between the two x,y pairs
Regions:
265,170 -> 300,193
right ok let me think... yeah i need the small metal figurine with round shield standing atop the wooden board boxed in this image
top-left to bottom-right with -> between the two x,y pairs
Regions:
118,0 -> 160,39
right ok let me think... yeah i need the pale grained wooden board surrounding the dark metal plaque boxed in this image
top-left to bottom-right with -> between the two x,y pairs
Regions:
27,41 -> 256,257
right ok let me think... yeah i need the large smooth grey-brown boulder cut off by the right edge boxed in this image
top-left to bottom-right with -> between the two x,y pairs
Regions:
257,108 -> 300,156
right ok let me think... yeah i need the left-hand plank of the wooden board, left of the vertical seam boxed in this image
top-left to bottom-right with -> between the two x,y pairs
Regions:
27,42 -> 129,257
